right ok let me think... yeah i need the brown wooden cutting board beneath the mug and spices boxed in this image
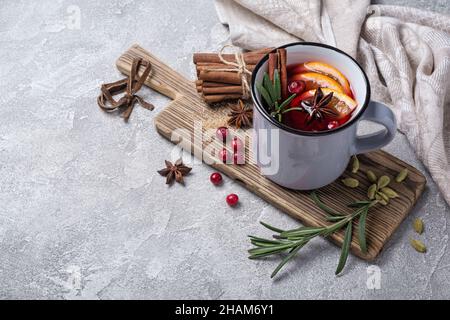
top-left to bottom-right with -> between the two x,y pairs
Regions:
117,45 -> 426,260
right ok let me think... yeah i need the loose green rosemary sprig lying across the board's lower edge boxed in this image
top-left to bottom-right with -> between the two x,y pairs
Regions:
248,191 -> 378,278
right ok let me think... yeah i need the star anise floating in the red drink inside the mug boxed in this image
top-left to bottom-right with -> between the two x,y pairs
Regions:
302,87 -> 338,124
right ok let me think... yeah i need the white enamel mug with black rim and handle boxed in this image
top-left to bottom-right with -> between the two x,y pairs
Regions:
251,42 -> 397,190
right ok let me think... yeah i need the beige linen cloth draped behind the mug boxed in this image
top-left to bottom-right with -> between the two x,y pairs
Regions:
216,0 -> 450,204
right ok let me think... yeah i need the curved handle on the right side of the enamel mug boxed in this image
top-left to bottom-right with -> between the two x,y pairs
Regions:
351,101 -> 397,154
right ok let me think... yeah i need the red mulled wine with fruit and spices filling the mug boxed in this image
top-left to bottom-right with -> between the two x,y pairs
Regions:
258,57 -> 358,131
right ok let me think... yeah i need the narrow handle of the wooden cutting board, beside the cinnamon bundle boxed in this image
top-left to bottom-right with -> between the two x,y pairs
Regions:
116,44 -> 197,100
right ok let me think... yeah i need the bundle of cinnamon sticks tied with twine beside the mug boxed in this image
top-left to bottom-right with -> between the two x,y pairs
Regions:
194,48 -> 274,103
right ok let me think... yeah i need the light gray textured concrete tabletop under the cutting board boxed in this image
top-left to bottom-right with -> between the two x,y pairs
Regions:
0,0 -> 450,299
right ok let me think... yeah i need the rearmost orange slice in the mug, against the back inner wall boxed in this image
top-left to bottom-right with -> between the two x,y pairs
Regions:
288,61 -> 352,96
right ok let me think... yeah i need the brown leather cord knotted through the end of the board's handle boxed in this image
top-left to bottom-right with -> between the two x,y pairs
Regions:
97,58 -> 155,121
